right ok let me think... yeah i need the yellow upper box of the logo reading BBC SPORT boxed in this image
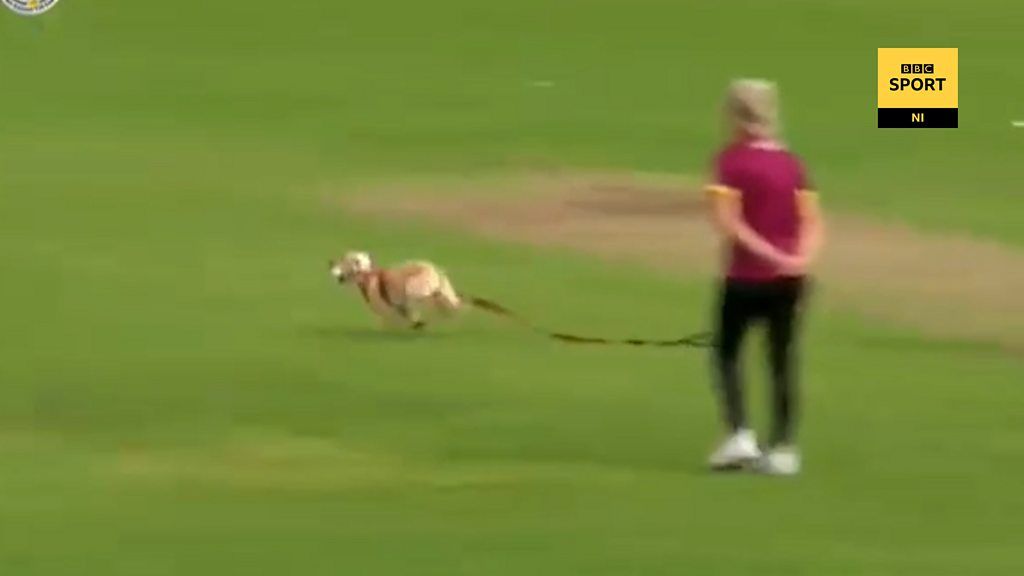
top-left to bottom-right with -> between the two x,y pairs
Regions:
879,48 -> 959,109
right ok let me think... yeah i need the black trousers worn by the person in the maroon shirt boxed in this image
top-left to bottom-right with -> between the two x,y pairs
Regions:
715,278 -> 807,446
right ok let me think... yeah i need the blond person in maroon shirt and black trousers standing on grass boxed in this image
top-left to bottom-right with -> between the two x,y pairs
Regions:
708,80 -> 823,476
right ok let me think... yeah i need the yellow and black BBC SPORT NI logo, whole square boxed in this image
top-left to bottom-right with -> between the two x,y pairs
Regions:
878,48 -> 959,128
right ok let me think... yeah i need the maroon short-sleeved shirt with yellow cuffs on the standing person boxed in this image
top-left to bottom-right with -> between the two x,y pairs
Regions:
712,140 -> 810,282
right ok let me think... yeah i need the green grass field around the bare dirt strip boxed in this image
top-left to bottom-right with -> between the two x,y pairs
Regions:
0,0 -> 1024,576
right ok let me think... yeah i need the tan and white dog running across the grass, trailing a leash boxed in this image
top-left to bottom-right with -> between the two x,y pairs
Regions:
330,252 -> 462,329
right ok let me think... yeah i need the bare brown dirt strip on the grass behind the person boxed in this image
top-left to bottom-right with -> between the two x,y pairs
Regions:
349,173 -> 1024,351
